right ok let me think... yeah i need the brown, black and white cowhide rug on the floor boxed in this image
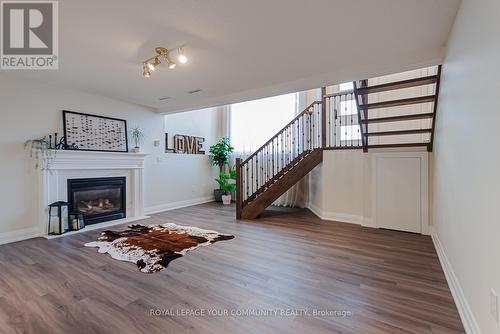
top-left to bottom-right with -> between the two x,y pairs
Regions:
85,223 -> 234,273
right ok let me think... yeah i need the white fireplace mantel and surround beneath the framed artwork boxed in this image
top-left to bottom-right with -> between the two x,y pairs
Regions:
39,150 -> 147,236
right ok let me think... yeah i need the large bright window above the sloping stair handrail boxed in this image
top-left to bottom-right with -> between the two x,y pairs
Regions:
230,93 -> 298,152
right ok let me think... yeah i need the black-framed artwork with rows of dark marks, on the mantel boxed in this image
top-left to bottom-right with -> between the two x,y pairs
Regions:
63,110 -> 128,152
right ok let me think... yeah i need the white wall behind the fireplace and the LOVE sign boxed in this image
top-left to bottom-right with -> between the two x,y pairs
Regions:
0,75 -> 218,241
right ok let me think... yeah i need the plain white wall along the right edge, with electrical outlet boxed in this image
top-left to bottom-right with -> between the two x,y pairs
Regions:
433,0 -> 500,333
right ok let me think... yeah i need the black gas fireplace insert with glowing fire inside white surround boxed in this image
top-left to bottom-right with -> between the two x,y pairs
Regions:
68,177 -> 126,225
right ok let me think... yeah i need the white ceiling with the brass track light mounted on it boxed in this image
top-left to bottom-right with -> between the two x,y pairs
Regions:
2,0 -> 460,112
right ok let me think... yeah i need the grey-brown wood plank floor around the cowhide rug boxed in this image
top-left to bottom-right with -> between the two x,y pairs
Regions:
0,203 -> 464,334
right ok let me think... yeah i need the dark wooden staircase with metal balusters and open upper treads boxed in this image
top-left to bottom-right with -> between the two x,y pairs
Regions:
236,66 -> 441,219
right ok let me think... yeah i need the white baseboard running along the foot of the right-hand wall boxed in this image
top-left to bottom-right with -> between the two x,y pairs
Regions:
431,229 -> 481,334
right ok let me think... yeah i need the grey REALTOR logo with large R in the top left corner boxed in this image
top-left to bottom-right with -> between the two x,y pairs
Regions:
0,0 -> 59,69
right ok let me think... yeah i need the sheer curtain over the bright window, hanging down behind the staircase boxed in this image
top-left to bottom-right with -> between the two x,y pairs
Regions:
225,90 -> 316,207
